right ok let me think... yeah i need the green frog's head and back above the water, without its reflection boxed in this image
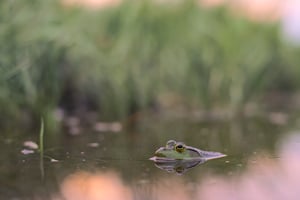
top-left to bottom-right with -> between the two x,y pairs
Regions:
151,140 -> 226,162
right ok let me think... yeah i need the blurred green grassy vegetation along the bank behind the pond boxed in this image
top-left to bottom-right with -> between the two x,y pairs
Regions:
0,0 -> 300,128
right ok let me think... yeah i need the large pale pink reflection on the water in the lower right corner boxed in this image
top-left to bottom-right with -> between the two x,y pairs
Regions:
197,135 -> 300,200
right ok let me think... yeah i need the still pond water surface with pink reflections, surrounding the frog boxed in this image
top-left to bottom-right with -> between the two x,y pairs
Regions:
0,113 -> 300,200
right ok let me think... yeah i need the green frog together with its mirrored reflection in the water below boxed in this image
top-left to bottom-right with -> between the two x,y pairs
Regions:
150,140 -> 226,174
